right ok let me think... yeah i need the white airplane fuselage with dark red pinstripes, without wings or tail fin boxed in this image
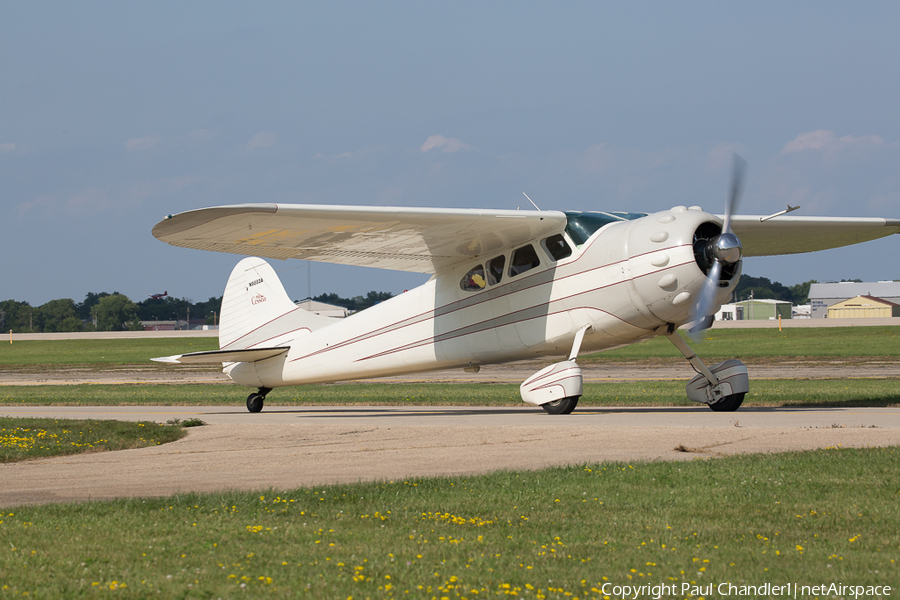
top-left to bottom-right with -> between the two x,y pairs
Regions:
223,207 -> 737,388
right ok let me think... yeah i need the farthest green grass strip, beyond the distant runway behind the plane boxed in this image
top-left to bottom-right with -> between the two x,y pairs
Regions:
0,327 -> 900,368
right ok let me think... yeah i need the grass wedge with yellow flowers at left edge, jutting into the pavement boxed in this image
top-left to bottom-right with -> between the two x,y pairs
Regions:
0,417 -> 184,463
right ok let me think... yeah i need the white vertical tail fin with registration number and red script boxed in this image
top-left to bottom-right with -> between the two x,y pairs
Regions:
219,257 -> 334,350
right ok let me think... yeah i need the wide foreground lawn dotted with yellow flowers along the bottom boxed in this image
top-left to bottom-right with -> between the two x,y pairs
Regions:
0,448 -> 900,599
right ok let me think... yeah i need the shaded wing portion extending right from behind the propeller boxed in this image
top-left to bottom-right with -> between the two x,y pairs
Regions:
731,215 -> 900,257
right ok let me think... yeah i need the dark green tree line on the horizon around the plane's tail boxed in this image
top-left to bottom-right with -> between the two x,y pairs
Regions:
0,291 -> 393,333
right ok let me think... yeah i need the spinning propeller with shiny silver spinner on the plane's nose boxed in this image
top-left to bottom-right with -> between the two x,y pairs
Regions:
688,154 -> 747,334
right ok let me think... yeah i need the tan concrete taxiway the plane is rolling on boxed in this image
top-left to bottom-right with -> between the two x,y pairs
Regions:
0,405 -> 900,507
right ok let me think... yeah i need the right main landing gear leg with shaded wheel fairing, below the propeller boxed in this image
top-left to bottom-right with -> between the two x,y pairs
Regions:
664,325 -> 750,412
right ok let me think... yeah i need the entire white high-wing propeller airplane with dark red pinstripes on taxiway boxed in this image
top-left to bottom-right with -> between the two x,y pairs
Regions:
153,161 -> 900,414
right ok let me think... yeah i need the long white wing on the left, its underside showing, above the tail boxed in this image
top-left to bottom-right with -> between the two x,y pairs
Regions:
153,204 -> 566,273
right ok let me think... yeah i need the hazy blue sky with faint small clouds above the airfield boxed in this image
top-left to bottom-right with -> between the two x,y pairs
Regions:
0,2 -> 900,305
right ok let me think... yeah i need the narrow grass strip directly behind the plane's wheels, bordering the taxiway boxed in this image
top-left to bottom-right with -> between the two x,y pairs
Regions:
0,379 -> 900,414
